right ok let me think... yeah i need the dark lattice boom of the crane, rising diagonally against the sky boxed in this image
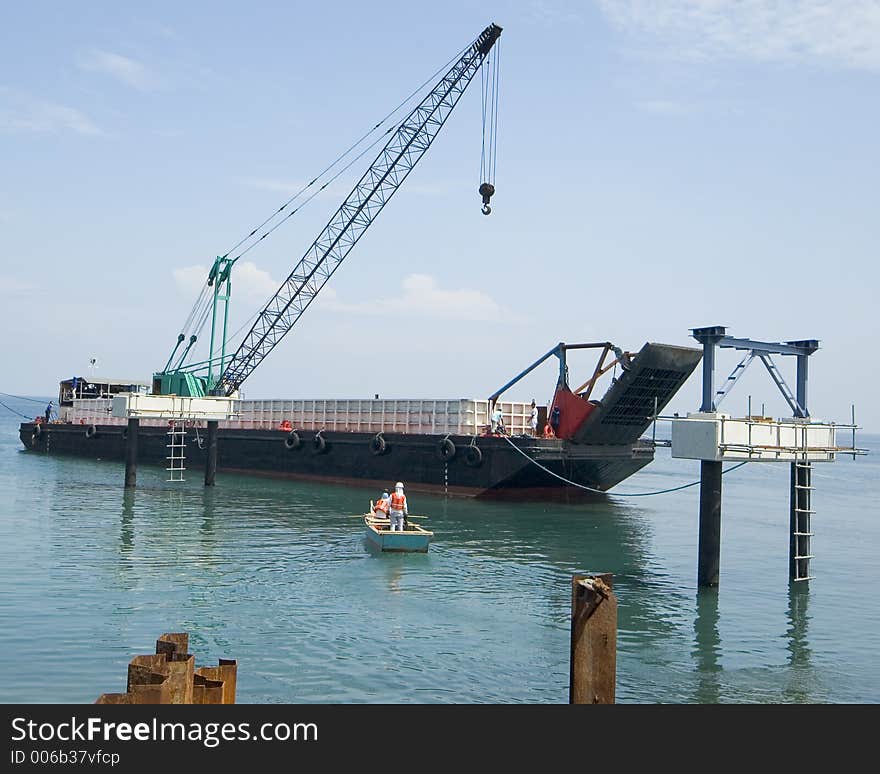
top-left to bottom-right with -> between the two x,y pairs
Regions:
214,24 -> 501,395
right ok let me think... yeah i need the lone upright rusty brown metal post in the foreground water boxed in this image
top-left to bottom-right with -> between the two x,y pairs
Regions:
568,573 -> 617,704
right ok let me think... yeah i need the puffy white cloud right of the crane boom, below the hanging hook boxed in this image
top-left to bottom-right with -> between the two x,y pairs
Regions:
320,274 -> 514,322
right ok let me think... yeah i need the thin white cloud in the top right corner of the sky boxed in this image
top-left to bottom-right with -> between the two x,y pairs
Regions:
598,0 -> 880,70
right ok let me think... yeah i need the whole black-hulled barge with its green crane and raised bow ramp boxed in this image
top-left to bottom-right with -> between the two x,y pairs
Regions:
19,24 -> 701,498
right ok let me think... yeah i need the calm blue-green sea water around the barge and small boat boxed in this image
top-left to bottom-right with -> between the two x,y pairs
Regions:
0,398 -> 880,704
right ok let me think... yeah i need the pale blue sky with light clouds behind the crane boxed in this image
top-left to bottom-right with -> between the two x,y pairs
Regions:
0,0 -> 880,432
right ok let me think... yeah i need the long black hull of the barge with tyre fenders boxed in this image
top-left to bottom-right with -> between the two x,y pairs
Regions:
19,422 -> 654,499
